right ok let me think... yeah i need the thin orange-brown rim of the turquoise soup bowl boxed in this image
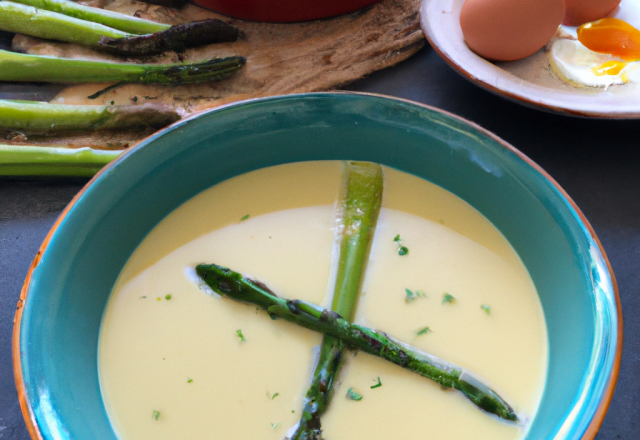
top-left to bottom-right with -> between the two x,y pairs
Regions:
12,91 -> 623,440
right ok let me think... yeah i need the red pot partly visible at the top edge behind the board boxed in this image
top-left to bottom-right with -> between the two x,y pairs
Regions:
192,0 -> 381,23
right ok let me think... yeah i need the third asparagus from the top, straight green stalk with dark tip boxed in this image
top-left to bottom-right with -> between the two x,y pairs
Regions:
0,50 -> 245,85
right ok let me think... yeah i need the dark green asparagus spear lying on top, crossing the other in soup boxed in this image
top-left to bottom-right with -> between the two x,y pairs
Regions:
196,264 -> 518,422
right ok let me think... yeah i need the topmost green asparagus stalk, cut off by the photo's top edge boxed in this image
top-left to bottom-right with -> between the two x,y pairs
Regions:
13,0 -> 171,35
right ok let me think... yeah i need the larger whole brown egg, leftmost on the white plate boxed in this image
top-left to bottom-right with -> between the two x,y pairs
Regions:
460,0 -> 564,61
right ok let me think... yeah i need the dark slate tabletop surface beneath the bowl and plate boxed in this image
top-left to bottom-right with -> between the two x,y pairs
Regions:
0,44 -> 640,440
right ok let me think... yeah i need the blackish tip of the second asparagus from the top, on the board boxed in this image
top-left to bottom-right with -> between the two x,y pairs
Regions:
99,18 -> 239,56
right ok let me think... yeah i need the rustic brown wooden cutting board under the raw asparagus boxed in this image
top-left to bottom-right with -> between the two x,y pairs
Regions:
12,0 -> 425,148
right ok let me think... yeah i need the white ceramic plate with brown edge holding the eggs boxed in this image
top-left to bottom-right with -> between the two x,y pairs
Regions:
420,0 -> 640,119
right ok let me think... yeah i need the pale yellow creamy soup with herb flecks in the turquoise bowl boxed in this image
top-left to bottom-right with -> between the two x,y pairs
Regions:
99,162 -> 547,440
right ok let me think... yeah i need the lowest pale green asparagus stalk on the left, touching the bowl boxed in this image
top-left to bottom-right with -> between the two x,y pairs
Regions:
0,145 -> 122,177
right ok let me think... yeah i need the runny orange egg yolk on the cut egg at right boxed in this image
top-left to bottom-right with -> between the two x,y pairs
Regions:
578,18 -> 640,61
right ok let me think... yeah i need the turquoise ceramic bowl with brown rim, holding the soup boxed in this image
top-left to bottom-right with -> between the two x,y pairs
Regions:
14,93 -> 622,440
